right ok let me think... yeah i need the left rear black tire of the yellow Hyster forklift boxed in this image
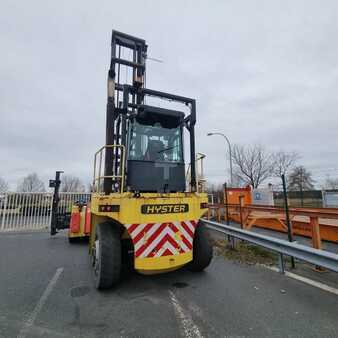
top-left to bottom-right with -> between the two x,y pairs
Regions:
92,222 -> 122,289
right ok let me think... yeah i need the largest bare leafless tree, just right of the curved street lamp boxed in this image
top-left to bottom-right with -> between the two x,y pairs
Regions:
232,144 -> 273,189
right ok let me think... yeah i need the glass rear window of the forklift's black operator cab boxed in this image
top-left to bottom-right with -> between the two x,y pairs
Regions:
129,121 -> 183,162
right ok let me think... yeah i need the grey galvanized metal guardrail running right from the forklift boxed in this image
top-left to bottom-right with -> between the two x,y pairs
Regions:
201,219 -> 338,273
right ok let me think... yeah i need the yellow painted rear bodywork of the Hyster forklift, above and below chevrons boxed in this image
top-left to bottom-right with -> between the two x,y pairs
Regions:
88,192 -> 208,274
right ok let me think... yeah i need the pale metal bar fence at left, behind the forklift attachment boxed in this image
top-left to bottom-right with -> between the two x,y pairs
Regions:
0,192 -> 90,232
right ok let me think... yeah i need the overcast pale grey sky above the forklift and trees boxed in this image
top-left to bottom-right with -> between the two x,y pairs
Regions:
0,0 -> 338,190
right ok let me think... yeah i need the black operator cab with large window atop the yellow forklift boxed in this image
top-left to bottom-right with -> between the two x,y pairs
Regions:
127,105 -> 185,192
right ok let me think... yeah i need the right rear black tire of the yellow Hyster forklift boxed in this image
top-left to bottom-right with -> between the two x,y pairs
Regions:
187,223 -> 212,272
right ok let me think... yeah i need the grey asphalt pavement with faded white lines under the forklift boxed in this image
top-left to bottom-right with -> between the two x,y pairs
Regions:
0,232 -> 338,338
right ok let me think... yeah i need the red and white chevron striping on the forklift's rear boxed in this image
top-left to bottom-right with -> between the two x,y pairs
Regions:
127,220 -> 197,258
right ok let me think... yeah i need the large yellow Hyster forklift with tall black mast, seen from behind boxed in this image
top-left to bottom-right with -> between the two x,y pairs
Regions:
54,31 -> 212,289
